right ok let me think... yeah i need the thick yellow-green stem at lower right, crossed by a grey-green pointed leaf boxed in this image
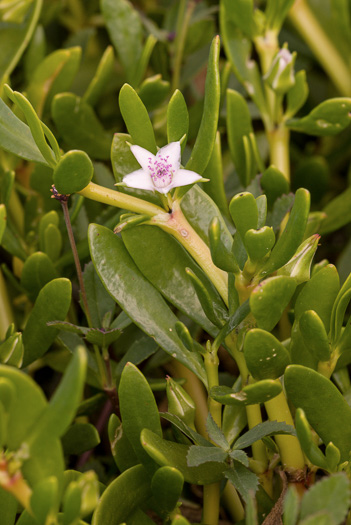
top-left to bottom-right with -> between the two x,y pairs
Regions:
265,392 -> 305,474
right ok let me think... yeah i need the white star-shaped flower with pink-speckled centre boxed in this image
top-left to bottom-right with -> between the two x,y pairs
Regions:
123,141 -> 203,195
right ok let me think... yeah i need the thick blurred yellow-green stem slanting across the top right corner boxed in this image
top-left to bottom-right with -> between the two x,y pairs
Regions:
289,0 -> 351,97
